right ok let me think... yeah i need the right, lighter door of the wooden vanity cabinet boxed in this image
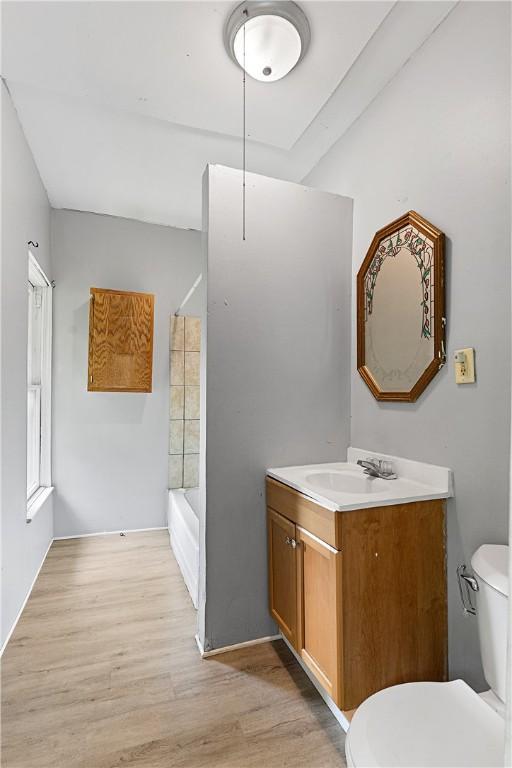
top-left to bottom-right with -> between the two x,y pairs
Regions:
297,527 -> 343,709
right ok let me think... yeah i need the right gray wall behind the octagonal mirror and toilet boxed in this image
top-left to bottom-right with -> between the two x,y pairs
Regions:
306,3 -> 510,687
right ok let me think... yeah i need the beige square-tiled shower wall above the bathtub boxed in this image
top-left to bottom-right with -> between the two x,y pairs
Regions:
169,315 -> 201,488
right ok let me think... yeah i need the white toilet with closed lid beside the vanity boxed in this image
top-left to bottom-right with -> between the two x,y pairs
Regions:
345,544 -> 509,768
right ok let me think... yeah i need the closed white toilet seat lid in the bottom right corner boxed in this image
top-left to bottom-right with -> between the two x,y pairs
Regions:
346,680 -> 505,768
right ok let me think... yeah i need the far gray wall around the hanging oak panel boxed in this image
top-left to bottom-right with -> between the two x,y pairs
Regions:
52,211 -> 202,536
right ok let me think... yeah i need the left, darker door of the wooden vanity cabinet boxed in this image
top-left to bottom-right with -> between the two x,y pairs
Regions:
267,509 -> 297,648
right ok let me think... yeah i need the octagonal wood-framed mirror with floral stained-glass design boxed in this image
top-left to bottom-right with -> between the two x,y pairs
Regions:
357,211 -> 445,402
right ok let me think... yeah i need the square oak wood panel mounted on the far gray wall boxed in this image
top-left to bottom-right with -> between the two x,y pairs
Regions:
87,288 -> 154,392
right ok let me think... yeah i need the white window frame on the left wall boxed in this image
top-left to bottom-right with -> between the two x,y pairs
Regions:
27,250 -> 53,522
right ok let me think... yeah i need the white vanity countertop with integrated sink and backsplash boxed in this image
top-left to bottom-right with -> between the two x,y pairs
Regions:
267,448 -> 453,512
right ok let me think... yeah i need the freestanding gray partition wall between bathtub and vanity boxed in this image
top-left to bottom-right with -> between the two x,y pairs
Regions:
200,166 -> 352,649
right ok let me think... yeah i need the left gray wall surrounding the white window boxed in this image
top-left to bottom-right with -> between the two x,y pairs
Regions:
0,82 -> 53,644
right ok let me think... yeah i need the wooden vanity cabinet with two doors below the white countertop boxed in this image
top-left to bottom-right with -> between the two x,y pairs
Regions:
267,478 -> 447,710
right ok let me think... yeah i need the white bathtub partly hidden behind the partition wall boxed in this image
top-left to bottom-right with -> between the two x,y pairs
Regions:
167,488 -> 199,608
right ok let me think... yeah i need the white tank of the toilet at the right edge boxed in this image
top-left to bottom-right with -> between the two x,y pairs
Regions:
471,544 -> 509,702
